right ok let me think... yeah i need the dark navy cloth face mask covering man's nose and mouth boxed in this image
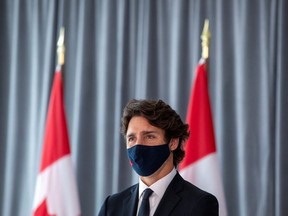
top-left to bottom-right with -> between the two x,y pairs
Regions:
127,144 -> 170,176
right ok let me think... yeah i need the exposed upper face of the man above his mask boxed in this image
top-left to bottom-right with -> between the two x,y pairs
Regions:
126,116 -> 165,148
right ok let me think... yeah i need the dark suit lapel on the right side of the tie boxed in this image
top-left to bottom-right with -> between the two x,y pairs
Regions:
154,173 -> 182,216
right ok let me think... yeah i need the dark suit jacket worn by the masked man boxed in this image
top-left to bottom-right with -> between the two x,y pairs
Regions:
99,173 -> 219,216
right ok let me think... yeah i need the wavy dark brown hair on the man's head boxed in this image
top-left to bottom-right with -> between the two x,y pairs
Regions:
121,99 -> 189,167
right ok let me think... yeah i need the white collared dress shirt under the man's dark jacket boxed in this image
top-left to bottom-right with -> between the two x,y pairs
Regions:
137,168 -> 177,216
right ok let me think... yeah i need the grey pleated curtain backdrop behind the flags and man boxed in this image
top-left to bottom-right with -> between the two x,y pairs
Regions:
0,0 -> 288,216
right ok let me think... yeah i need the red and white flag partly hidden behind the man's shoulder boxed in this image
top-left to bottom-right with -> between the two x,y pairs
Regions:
179,61 -> 227,216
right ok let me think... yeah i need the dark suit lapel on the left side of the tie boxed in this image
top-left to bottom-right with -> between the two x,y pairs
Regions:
122,184 -> 139,216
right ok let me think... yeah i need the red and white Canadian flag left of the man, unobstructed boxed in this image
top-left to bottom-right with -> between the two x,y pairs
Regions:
33,69 -> 81,216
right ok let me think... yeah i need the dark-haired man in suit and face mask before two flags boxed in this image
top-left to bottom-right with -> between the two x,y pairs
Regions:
99,99 -> 219,216
